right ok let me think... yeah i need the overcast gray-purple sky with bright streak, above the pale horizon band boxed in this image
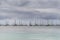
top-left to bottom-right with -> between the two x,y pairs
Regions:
0,0 -> 60,24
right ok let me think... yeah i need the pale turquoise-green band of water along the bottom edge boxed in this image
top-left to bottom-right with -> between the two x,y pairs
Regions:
0,33 -> 60,40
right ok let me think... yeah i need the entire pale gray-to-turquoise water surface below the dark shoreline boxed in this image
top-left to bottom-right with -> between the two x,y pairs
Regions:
0,26 -> 60,40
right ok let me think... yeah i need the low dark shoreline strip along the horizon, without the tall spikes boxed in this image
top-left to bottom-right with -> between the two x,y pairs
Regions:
0,22 -> 60,26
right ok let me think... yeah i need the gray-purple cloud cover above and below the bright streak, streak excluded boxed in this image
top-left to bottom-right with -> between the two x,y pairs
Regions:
0,0 -> 60,19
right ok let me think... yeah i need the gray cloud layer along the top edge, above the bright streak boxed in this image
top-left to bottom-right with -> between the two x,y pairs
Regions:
3,0 -> 60,8
